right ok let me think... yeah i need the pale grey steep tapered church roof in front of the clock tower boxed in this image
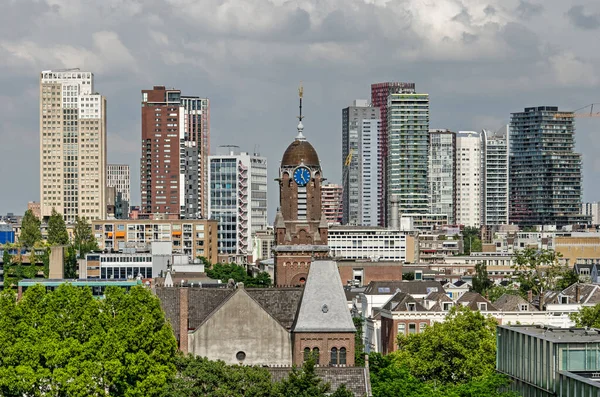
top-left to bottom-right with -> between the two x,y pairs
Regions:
294,260 -> 356,332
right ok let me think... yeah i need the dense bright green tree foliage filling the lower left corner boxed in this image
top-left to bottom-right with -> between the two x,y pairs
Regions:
0,284 -> 177,397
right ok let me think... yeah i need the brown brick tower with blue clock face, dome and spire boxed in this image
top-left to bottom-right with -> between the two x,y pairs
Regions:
273,87 -> 329,286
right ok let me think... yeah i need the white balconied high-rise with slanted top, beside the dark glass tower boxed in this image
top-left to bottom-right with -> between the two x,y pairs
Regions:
481,126 -> 509,226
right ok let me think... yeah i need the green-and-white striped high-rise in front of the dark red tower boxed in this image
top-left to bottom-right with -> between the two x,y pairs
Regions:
387,93 -> 429,219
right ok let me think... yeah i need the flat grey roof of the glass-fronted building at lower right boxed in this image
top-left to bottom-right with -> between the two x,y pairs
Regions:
498,325 -> 600,343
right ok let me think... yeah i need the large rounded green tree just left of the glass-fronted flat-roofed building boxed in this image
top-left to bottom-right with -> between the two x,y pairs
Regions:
394,307 -> 497,384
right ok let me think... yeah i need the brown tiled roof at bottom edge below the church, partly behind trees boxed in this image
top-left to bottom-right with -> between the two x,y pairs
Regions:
267,367 -> 372,397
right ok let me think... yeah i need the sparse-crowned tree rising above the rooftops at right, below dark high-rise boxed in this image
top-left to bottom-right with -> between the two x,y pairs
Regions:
512,248 -> 568,300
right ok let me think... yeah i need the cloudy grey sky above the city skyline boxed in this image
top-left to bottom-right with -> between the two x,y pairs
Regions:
0,0 -> 600,221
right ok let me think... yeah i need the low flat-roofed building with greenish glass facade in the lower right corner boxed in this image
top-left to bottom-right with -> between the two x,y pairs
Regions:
496,325 -> 600,397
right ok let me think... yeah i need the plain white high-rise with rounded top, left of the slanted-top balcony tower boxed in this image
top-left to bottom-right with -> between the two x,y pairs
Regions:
455,131 -> 482,227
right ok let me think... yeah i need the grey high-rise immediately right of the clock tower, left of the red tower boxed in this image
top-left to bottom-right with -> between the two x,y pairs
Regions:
342,100 -> 385,226
